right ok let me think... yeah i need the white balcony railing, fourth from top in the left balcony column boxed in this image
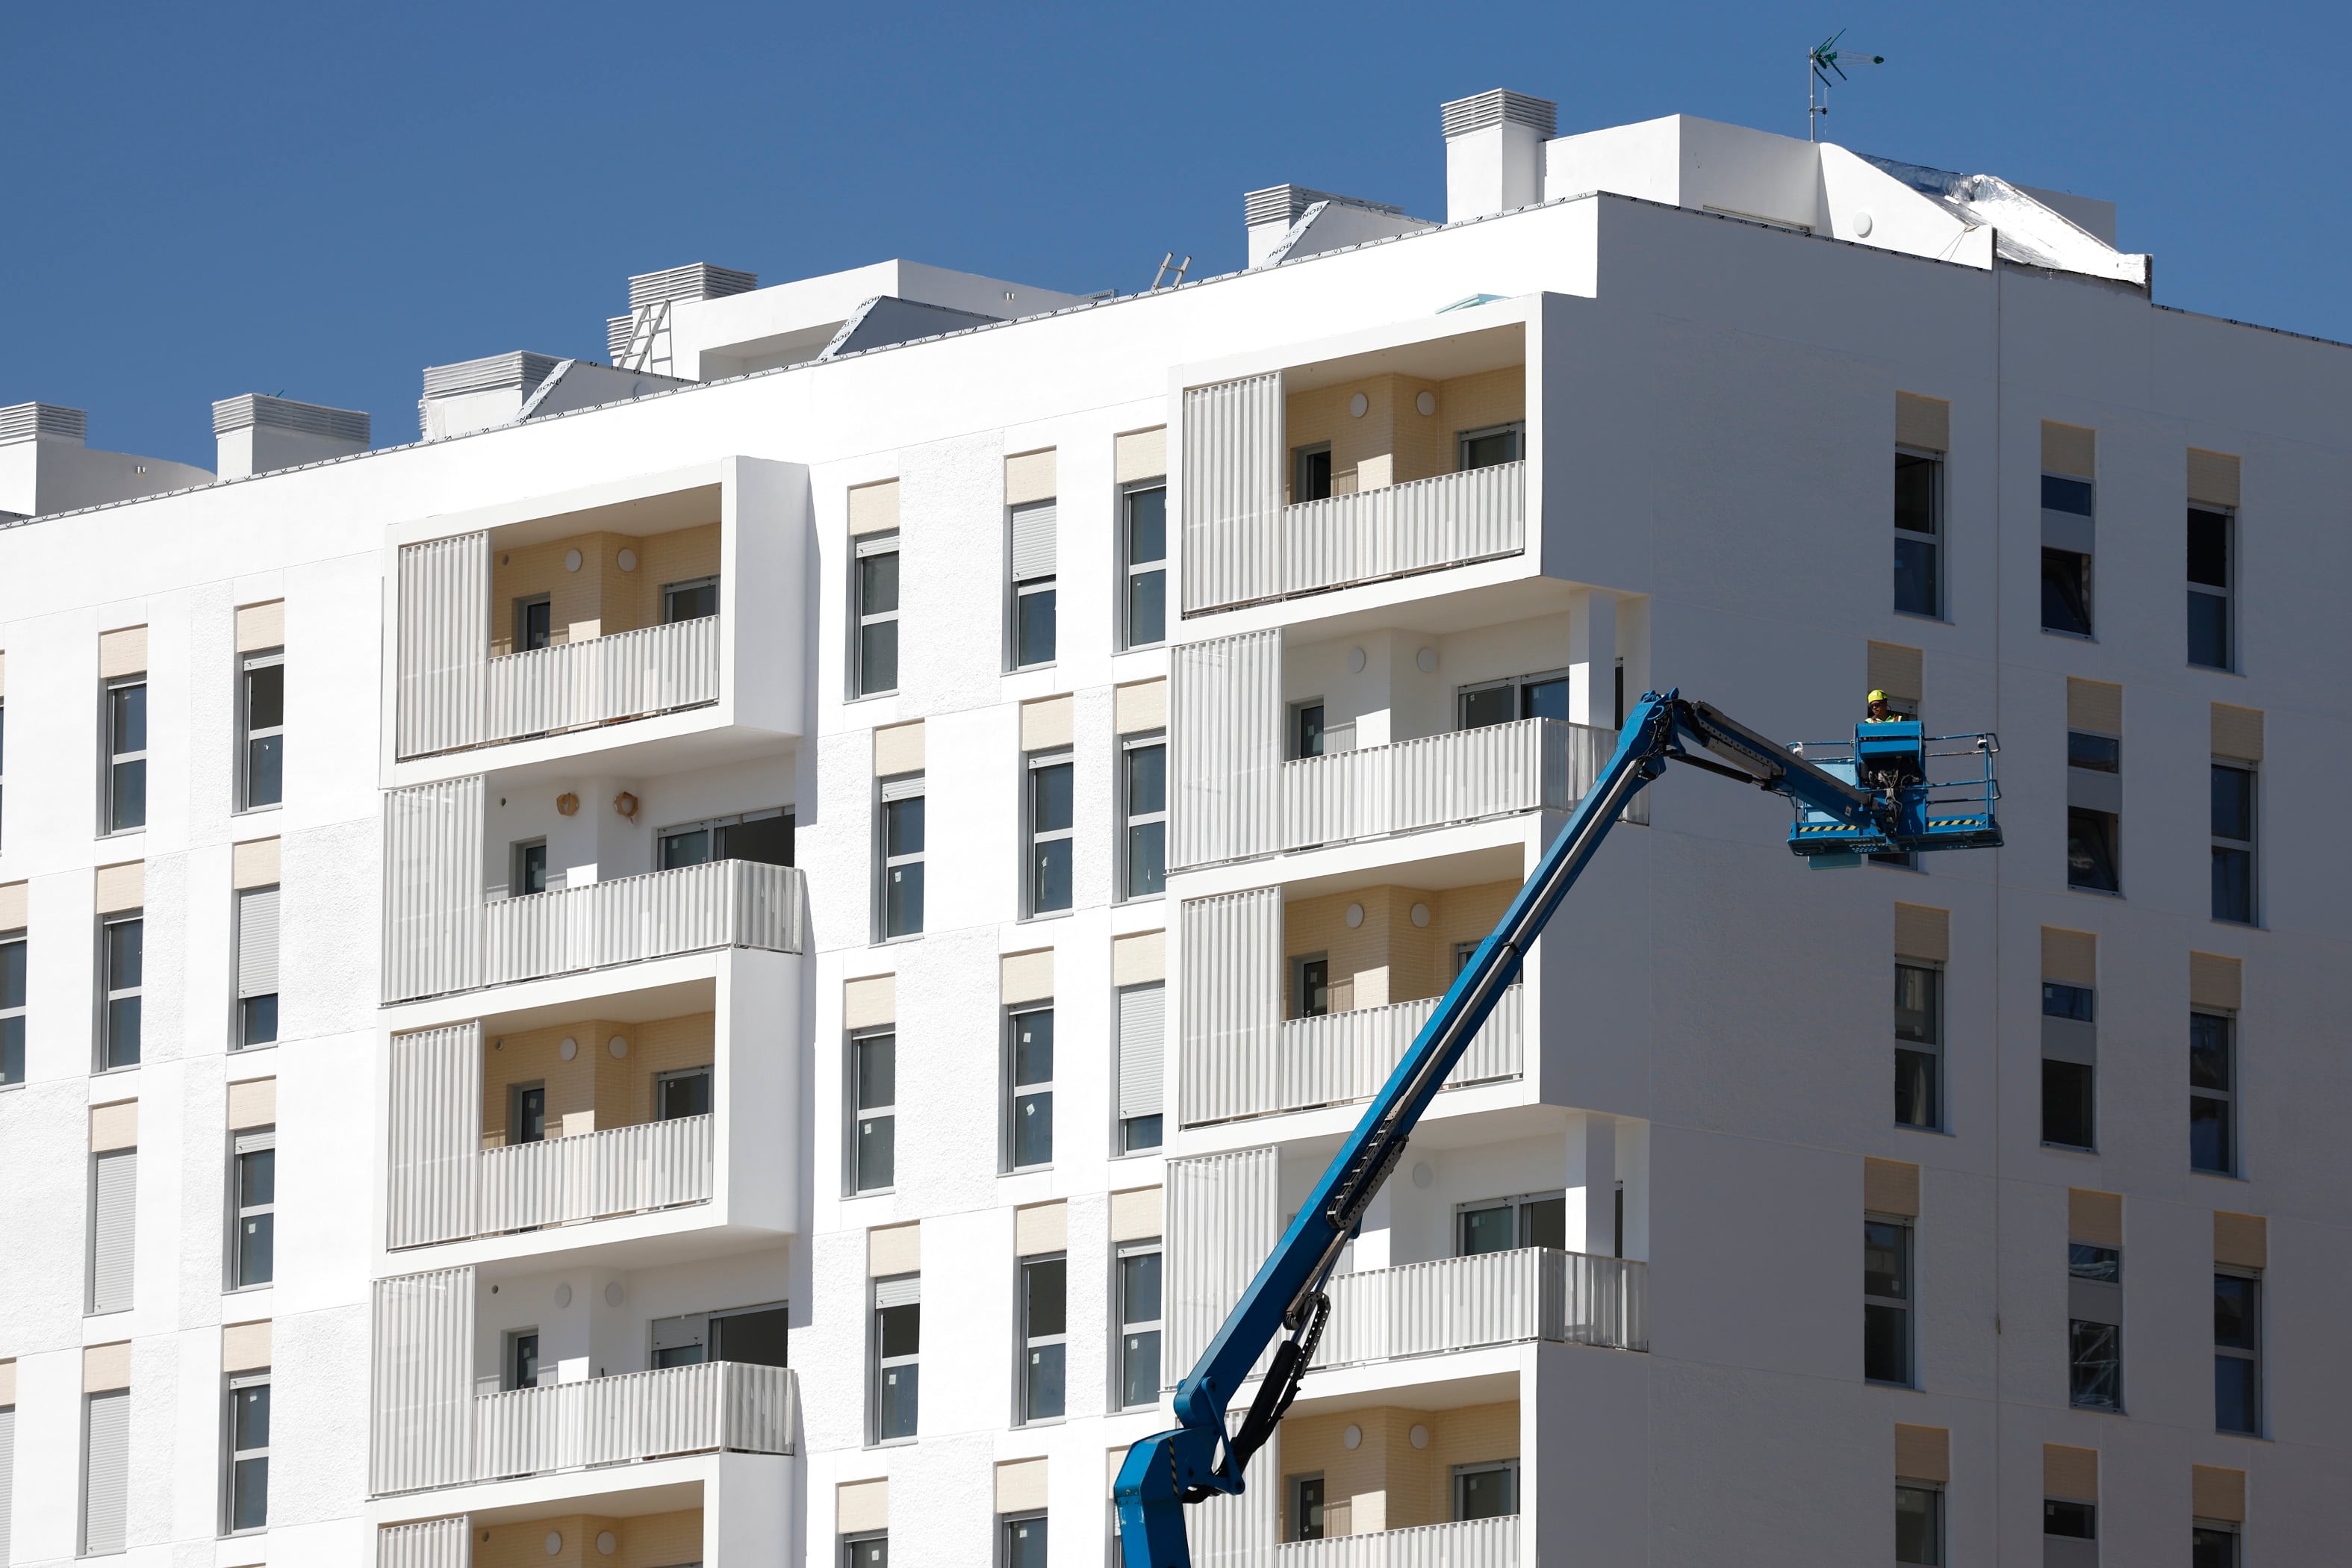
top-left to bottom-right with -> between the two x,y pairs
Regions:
473,1361 -> 800,1481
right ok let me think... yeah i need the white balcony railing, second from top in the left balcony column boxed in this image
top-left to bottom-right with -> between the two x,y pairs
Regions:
482,860 -> 802,985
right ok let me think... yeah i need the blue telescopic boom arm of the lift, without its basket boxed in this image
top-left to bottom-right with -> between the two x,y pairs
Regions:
1113,691 -> 1990,1568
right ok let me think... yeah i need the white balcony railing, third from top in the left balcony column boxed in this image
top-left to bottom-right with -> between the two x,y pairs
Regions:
473,1117 -> 712,1236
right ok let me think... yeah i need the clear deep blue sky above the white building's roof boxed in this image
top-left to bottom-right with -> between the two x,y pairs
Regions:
0,0 -> 2352,468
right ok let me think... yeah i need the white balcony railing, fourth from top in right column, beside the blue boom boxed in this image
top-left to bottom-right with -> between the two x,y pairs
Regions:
1315,1246 -> 1649,1366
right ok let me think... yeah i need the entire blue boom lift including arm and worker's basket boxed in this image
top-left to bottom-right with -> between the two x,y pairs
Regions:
1113,691 -> 2002,1568
